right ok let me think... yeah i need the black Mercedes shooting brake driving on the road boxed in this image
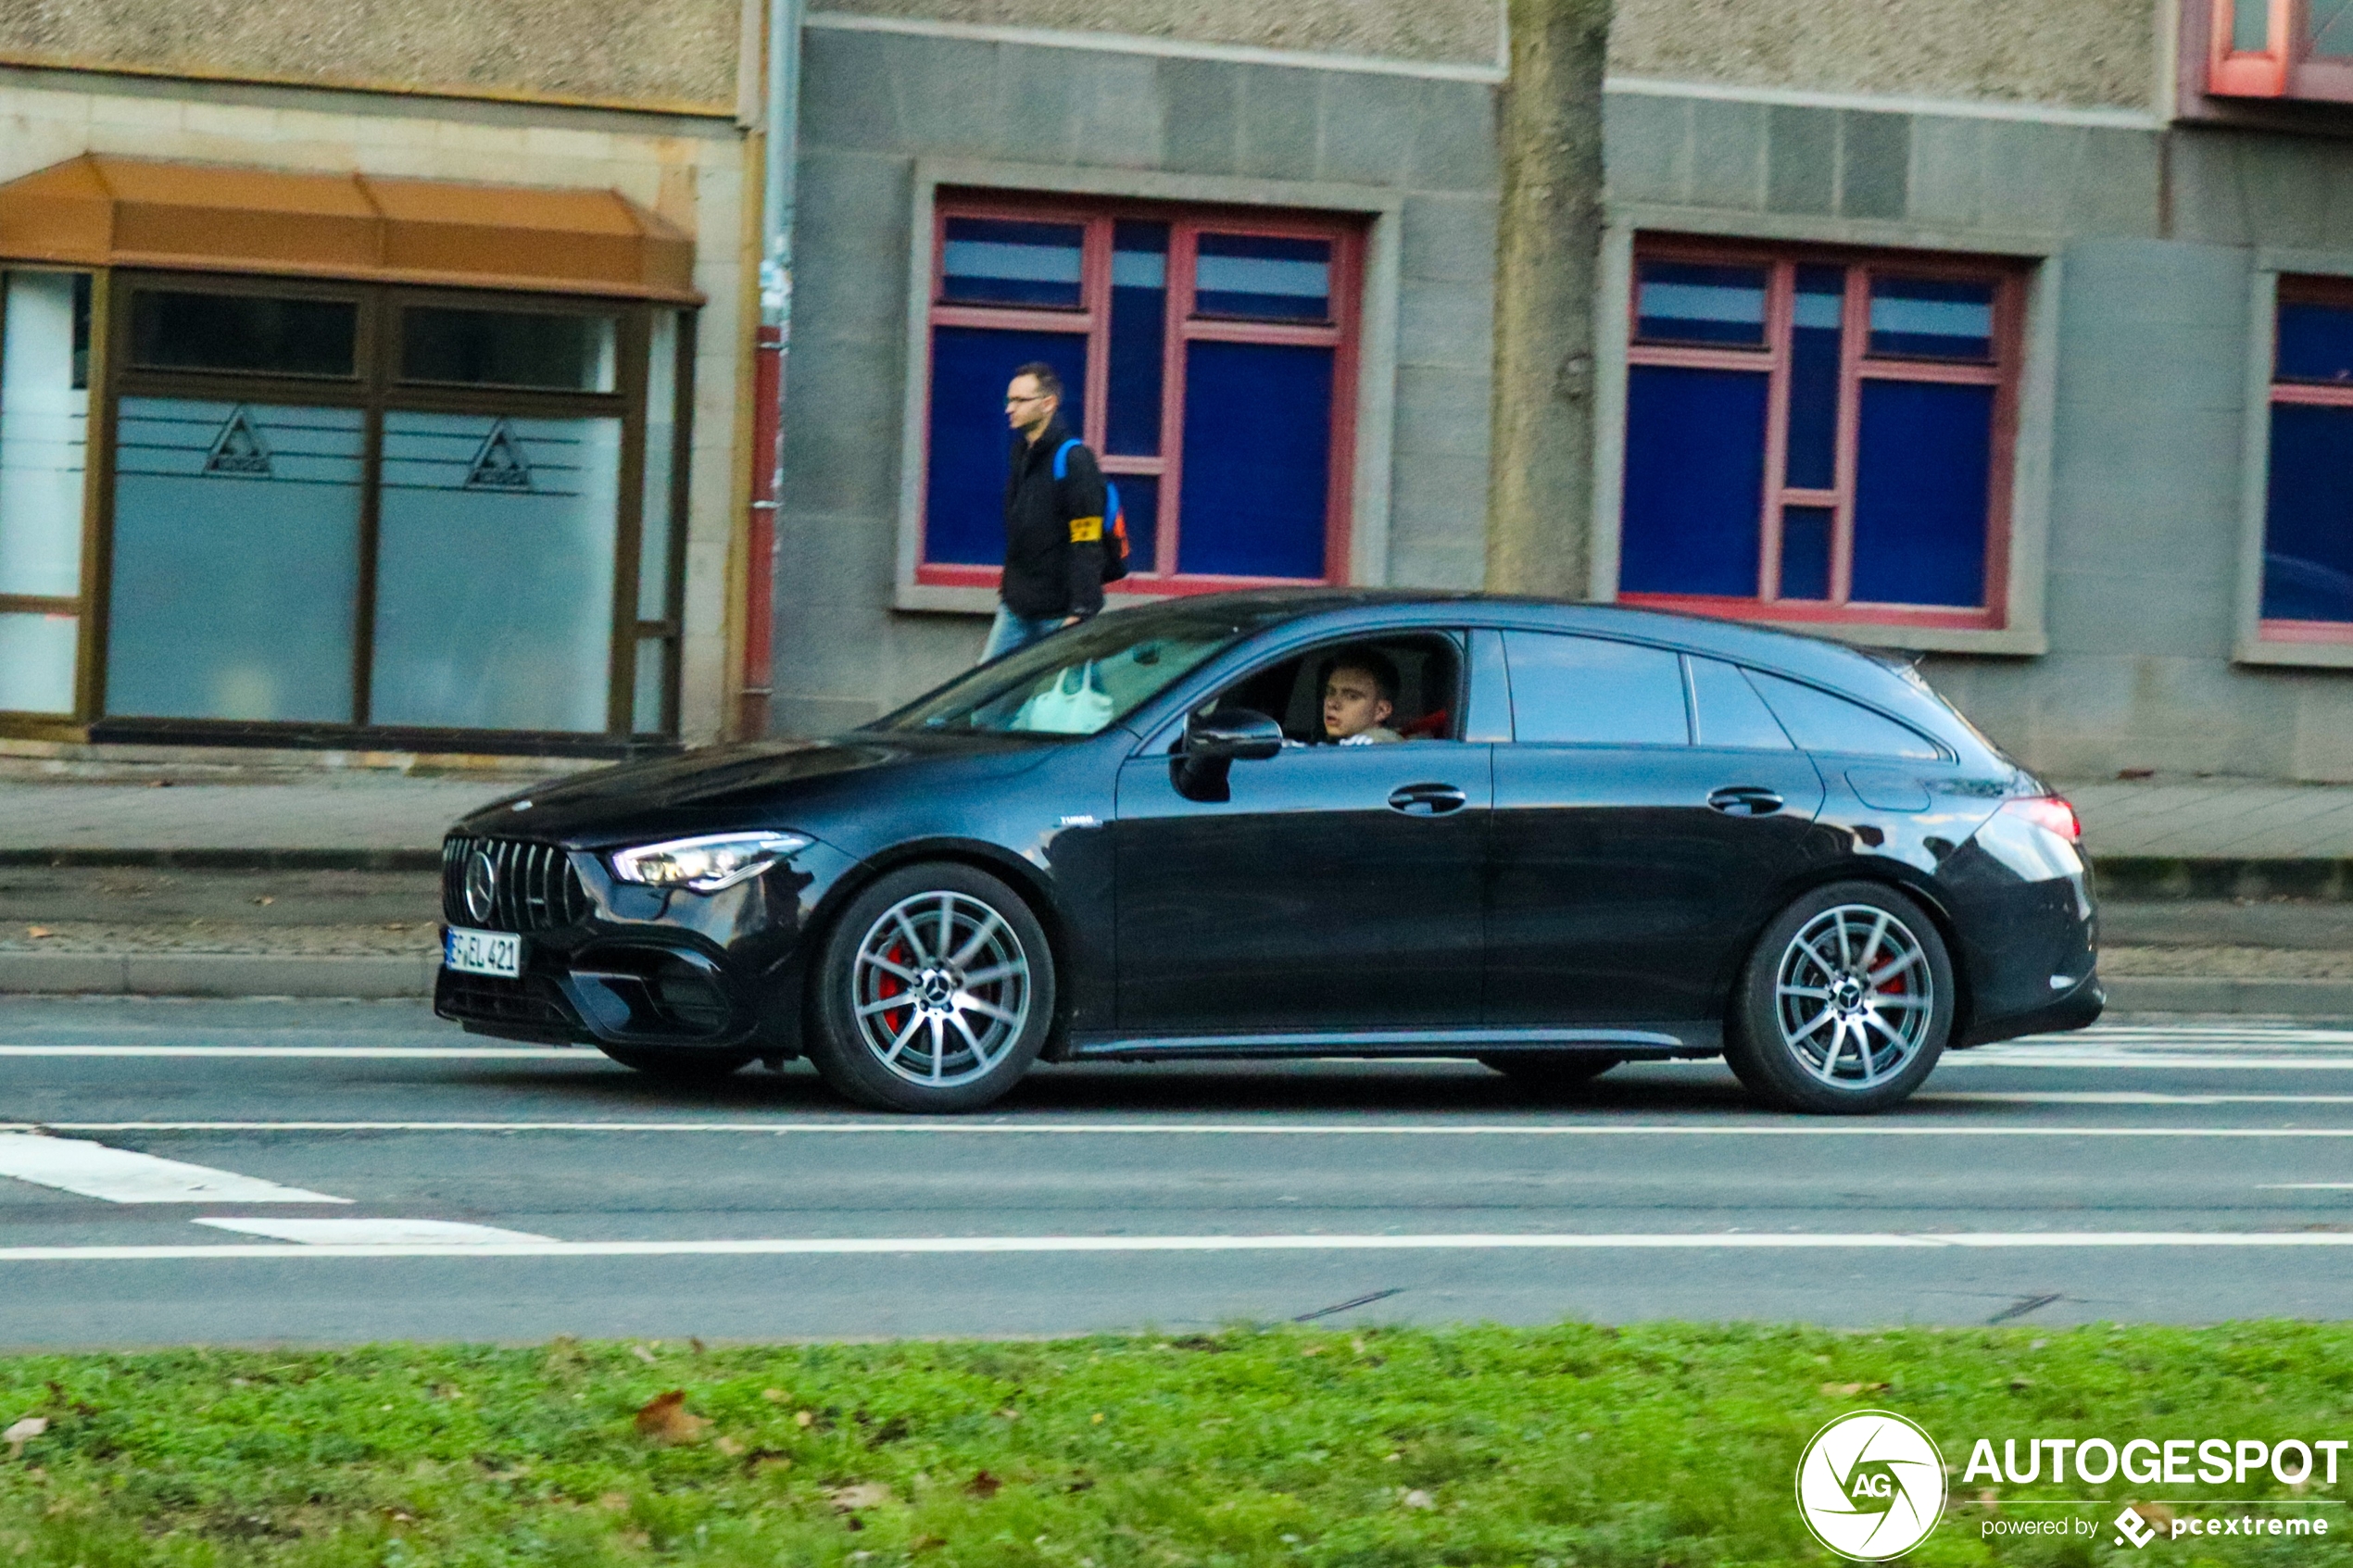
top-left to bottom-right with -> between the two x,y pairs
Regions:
435,590 -> 2101,1112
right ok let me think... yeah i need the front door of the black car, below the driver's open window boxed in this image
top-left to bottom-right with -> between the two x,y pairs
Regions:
1118,630 -> 1491,1036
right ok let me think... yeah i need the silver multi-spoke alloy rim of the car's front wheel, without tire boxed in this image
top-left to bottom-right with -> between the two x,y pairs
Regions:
849,891 -> 1031,1088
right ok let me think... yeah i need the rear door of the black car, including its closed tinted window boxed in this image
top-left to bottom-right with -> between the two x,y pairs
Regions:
1485,630 -> 1824,1027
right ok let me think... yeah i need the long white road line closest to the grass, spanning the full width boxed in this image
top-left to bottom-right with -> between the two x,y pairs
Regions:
0,1229 -> 2353,1262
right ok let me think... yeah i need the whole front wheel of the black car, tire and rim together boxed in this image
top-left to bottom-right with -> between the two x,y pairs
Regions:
807,863 -> 1056,1112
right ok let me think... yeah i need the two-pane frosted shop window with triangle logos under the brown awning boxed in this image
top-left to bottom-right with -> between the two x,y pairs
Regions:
73,275 -> 692,735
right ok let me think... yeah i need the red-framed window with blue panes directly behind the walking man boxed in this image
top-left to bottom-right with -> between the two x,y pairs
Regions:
915,197 -> 1358,593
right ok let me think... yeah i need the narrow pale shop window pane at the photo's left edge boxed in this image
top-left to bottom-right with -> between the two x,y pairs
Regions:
0,270 -> 92,715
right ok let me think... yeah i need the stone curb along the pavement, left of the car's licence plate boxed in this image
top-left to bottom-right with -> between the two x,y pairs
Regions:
0,952 -> 440,1001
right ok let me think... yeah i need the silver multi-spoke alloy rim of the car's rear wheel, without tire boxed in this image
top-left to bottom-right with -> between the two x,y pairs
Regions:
1774,903 -> 1936,1091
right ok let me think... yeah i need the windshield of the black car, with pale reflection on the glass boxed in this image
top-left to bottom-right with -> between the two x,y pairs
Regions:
873,607 -> 1297,735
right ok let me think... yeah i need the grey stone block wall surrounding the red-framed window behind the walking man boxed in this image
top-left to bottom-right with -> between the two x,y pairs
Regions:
774,26 -> 1496,731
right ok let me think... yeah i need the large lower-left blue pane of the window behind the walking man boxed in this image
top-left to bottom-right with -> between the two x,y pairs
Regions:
923,327 -> 1087,567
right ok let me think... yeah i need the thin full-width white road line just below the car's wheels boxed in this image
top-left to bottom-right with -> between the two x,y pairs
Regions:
21,1117 -> 2353,1138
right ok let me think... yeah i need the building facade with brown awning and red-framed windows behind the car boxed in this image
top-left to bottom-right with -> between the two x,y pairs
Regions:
13,0 -> 2353,781
